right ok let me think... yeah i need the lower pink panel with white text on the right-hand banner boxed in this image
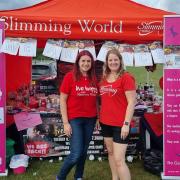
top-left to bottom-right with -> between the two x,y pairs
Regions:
164,69 -> 180,176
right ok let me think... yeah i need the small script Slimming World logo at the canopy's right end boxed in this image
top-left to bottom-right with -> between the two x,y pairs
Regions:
137,21 -> 163,36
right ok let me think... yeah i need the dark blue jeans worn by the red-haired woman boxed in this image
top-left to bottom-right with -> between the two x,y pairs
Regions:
57,117 -> 96,180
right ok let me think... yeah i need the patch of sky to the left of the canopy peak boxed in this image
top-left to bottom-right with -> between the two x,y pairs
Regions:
0,0 -> 46,10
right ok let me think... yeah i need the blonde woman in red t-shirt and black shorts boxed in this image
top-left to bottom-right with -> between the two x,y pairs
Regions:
100,49 -> 136,180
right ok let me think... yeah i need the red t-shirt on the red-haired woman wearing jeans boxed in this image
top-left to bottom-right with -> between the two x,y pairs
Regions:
60,72 -> 98,120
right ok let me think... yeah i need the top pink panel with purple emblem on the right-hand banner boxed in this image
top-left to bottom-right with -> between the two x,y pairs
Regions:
164,15 -> 180,46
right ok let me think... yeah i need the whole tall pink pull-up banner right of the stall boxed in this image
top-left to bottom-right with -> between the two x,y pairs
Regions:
163,15 -> 180,179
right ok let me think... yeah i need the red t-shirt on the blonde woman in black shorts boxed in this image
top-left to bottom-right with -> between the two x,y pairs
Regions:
100,72 -> 136,127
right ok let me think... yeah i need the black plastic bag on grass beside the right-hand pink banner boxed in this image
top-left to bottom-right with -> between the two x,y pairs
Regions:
143,149 -> 163,175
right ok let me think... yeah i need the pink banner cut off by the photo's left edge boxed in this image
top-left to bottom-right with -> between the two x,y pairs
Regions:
0,19 -> 6,173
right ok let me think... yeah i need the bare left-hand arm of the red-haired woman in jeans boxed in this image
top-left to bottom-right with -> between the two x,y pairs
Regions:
60,92 -> 72,136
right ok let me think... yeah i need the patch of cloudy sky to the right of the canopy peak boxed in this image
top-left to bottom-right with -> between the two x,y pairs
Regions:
132,0 -> 180,14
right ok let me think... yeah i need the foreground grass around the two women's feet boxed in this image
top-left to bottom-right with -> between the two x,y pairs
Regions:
0,159 -> 160,180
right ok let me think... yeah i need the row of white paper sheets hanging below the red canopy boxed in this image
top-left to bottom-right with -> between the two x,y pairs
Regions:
0,38 -> 180,67
